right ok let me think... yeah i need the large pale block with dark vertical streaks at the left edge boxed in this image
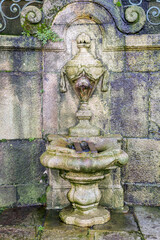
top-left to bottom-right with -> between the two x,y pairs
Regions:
0,72 -> 41,139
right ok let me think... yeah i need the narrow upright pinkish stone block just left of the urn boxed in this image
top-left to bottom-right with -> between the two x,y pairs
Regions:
43,73 -> 59,134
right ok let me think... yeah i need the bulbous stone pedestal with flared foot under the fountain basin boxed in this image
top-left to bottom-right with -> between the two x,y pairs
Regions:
60,172 -> 110,227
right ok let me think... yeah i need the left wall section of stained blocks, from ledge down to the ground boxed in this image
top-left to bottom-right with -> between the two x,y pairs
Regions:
0,36 -> 46,207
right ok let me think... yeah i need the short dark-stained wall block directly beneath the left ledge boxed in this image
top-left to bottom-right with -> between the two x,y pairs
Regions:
0,50 -> 42,72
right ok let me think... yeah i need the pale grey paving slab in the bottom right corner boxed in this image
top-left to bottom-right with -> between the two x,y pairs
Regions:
134,207 -> 160,240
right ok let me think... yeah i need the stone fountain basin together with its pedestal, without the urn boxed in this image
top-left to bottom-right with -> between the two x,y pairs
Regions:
40,135 -> 128,227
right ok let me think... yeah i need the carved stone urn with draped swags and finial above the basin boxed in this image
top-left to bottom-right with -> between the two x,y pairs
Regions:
60,33 -> 108,136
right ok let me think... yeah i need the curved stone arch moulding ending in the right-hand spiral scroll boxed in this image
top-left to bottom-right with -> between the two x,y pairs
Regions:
43,0 -> 146,38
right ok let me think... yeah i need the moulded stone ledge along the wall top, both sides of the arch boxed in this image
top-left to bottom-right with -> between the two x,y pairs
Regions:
0,34 -> 160,52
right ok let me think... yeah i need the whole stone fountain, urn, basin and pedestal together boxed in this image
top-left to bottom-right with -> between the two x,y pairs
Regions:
41,33 -> 128,227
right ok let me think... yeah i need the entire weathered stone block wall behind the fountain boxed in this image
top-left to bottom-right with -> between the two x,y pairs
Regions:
0,7 -> 160,207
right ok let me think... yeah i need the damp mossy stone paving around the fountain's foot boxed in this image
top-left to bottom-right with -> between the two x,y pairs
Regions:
0,206 -> 160,240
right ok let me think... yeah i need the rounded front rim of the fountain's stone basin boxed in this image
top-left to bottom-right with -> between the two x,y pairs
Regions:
40,150 -> 128,172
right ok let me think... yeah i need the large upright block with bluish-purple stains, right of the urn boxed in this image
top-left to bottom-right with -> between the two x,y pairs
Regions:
110,73 -> 148,137
